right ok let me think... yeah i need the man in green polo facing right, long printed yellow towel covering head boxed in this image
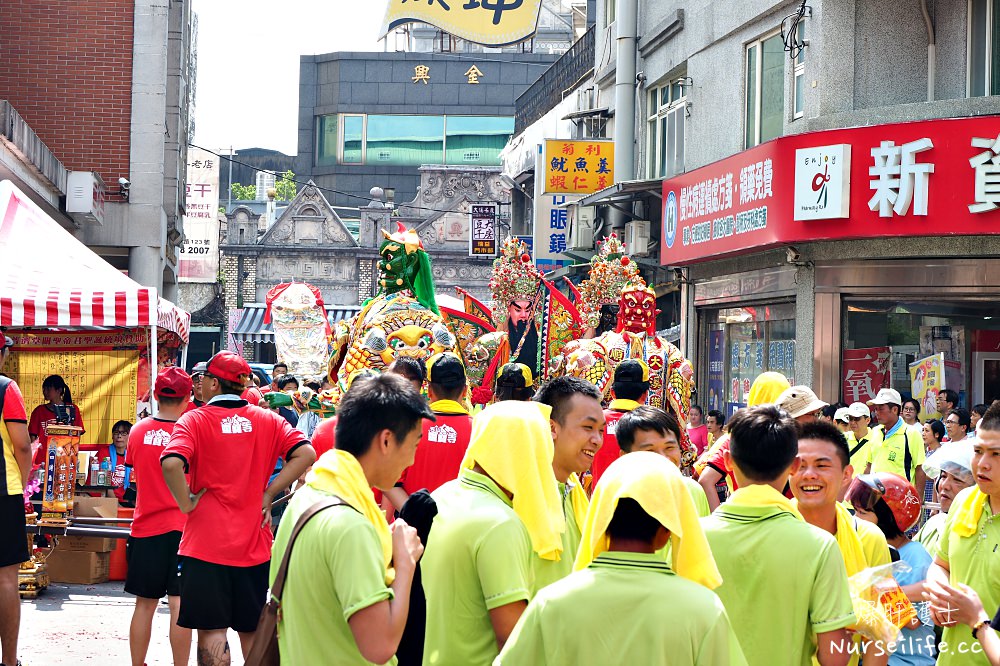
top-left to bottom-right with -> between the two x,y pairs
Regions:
420,400 -> 572,666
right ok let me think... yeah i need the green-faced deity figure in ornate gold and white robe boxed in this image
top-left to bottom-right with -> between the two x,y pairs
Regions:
329,224 -> 455,400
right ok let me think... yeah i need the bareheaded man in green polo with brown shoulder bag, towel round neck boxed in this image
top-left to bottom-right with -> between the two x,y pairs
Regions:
270,374 -> 434,664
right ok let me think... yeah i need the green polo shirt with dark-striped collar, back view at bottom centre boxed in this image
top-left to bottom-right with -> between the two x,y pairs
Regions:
494,551 -> 747,666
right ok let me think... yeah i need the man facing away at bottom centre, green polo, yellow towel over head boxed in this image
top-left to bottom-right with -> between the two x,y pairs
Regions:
494,451 -> 746,666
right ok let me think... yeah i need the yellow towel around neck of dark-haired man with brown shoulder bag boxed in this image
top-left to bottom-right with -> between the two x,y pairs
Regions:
306,449 -> 396,585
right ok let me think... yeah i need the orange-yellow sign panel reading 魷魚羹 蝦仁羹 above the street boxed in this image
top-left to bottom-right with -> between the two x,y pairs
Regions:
544,139 -> 615,194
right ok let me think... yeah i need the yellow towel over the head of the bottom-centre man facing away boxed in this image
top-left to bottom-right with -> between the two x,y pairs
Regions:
573,451 -> 722,589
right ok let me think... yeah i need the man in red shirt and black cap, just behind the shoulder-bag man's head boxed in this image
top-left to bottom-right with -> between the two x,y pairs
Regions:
386,352 -> 472,510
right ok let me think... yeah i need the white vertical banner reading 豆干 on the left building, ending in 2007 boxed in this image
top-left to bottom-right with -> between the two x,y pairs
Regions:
184,148 -> 225,282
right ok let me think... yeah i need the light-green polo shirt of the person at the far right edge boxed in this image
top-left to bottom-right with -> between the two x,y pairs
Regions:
937,486 -> 1000,666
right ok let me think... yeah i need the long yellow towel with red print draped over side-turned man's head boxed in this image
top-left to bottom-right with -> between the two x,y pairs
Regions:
462,400 -> 566,560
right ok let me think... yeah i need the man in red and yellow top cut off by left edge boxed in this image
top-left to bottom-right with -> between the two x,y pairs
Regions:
0,331 -> 31,666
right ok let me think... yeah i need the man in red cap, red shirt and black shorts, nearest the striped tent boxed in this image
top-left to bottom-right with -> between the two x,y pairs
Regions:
125,367 -> 191,666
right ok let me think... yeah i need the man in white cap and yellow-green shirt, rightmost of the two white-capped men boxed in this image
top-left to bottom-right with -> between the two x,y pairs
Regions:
865,389 -> 927,496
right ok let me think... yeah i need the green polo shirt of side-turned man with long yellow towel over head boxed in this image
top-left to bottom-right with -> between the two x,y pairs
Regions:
420,470 -> 534,666
